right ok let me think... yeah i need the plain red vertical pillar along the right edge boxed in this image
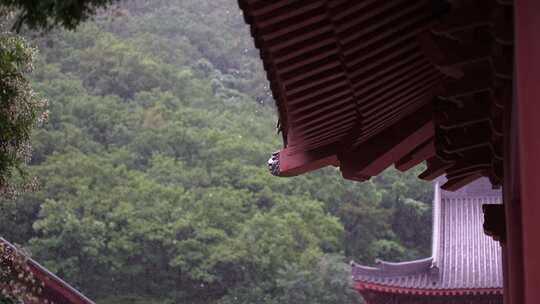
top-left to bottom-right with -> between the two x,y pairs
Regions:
509,0 -> 540,304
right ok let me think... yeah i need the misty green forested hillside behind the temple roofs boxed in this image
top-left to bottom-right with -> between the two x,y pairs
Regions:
0,0 -> 431,304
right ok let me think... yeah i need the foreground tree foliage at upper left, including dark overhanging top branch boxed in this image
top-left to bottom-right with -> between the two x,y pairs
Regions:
0,0 -> 122,197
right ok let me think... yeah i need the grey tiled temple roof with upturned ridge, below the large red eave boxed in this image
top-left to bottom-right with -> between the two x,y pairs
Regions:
352,178 -> 503,294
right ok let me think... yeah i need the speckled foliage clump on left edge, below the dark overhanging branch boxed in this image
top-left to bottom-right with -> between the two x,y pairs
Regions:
0,12 -> 47,197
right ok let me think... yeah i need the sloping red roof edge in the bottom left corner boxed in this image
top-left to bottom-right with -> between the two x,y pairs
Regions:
0,237 -> 95,304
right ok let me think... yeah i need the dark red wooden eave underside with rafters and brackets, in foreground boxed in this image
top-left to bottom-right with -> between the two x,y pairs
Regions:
239,0 -> 513,190
